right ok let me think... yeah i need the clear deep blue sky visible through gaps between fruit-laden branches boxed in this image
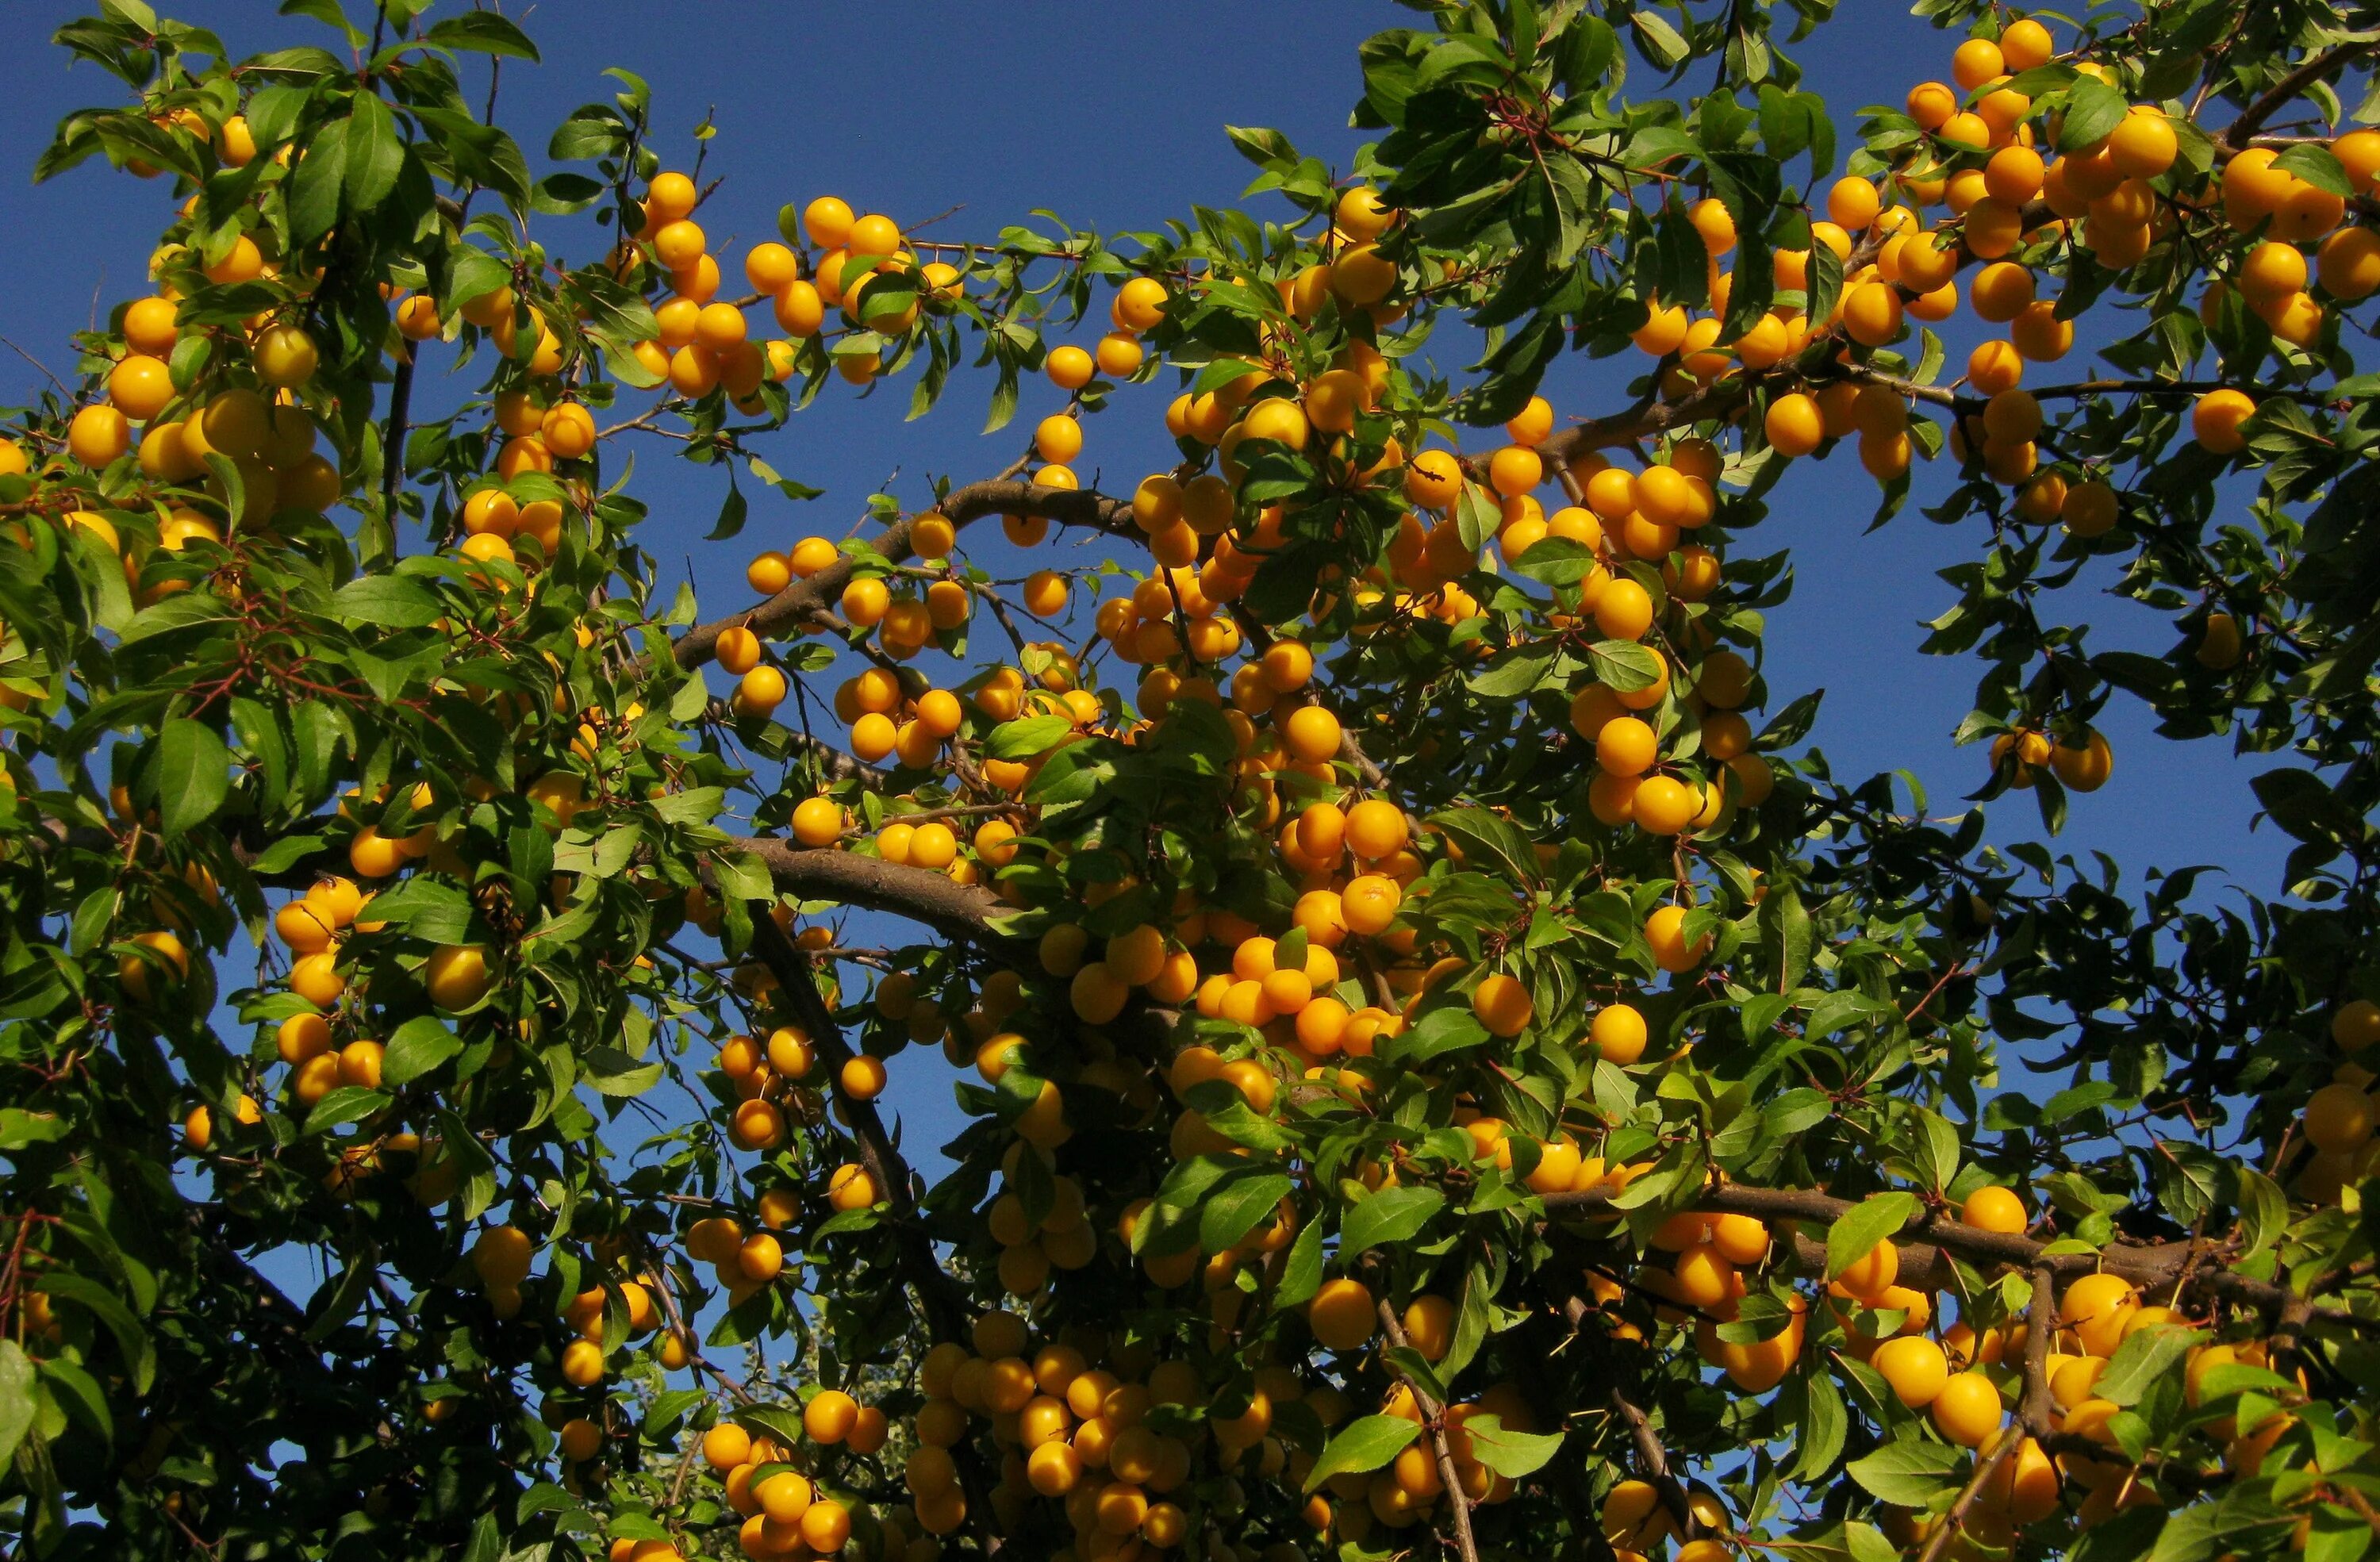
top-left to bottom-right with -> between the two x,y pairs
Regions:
0,0 -> 2285,1209
